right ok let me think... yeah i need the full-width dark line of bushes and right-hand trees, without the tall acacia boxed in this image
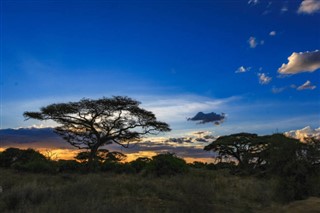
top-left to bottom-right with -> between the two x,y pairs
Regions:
0,133 -> 320,202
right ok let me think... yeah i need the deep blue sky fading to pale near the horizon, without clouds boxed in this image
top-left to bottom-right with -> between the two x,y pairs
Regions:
1,0 -> 320,135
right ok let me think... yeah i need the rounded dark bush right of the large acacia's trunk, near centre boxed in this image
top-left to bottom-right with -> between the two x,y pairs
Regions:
146,153 -> 188,176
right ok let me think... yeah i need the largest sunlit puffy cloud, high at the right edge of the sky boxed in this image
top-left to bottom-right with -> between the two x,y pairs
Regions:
278,50 -> 320,74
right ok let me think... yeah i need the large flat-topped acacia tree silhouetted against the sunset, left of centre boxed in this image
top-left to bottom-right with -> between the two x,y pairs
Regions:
23,96 -> 171,165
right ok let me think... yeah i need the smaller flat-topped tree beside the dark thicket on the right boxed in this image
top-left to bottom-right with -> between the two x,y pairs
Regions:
204,133 -> 266,171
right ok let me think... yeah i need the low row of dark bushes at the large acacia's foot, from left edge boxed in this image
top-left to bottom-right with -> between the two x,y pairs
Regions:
0,148 -> 189,176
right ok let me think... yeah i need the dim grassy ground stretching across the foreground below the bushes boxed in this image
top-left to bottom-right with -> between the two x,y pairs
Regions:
0,169 -> 320,213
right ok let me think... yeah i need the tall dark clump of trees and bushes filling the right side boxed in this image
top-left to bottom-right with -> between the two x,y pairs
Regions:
204,133 -> 320,202
